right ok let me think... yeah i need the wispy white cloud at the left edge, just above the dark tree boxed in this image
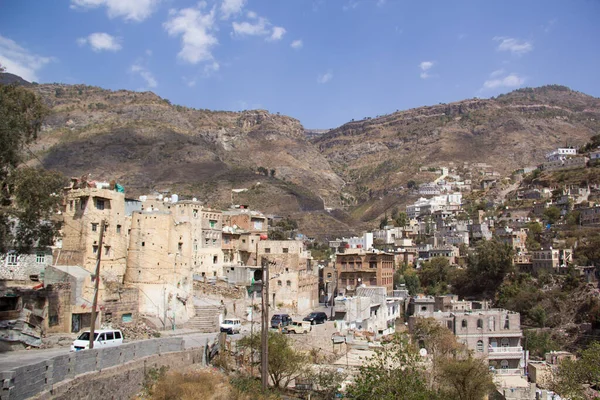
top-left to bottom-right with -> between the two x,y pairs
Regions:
0,35 -> 54,82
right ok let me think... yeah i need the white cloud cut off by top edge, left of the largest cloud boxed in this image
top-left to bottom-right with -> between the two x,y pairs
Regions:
71,0 -> 161,22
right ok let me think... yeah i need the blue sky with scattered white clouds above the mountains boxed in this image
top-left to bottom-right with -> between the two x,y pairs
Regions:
0,0 -> 600,128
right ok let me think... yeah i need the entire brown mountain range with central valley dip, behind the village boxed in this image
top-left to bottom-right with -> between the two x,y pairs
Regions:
0,74 -> 600,237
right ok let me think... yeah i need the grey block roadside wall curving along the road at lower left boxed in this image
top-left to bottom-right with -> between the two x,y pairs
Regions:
0,338 -> 189,400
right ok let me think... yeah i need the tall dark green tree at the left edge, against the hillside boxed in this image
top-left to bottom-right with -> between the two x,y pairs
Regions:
0,85 -> 64,252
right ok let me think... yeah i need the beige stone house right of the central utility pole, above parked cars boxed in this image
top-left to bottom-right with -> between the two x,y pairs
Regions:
258,240 -> 319,313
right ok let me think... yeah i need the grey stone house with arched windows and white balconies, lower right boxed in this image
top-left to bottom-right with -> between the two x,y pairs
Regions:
408,307 -> 527,375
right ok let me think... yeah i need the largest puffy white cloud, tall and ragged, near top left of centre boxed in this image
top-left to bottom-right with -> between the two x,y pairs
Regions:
163,3 -> 219,64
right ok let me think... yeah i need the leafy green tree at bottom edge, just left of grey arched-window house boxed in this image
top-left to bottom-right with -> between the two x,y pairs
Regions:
346,334 -> 439,400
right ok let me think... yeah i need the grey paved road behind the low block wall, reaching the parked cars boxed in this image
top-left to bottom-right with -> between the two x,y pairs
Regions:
0,331 -> 220,372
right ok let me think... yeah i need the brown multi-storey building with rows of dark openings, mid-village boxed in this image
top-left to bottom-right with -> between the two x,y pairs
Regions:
336,250 -> 394,295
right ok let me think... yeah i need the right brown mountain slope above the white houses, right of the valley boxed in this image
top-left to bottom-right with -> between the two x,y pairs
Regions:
312,85 -> 600,195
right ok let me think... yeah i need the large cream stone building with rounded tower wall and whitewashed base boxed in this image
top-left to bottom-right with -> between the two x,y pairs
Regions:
125,197 -> 223,324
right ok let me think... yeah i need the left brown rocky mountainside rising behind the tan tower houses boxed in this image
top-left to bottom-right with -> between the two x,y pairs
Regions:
14,80 -> 343,220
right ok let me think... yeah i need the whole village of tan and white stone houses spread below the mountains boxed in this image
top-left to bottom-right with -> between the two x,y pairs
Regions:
0,142 -> 600,399
